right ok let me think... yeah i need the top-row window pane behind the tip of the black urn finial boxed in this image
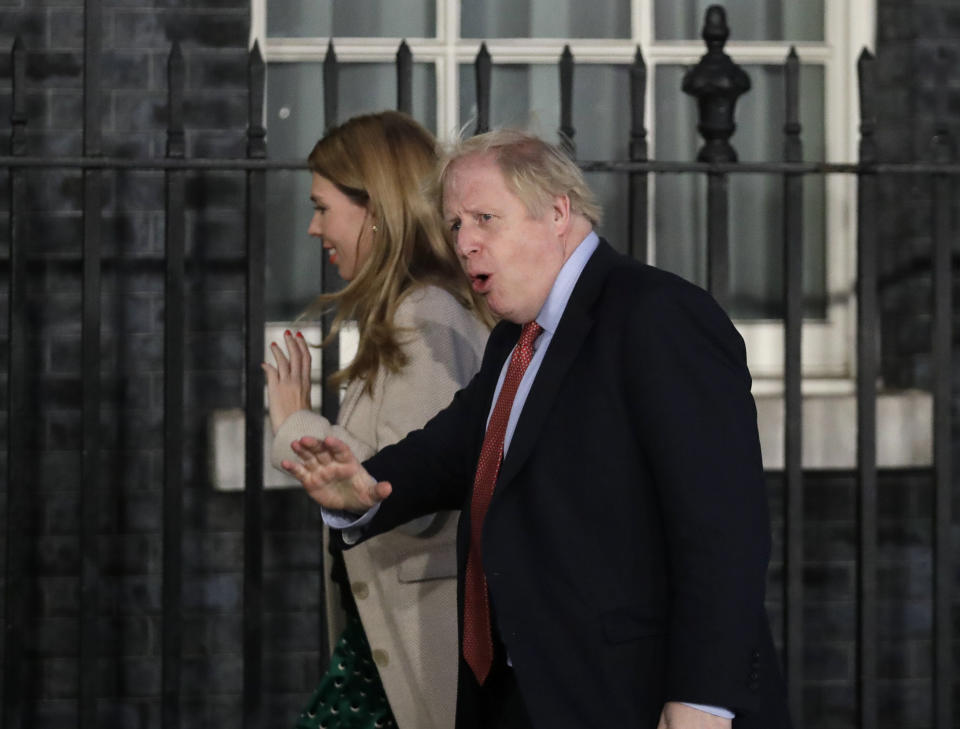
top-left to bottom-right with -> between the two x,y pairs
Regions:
654,0 -> 824,41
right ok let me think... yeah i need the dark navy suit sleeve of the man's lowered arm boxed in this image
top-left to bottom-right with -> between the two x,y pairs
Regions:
625,286 -> 770,711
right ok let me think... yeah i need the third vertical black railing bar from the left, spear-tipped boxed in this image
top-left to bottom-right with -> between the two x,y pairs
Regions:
161,41 -> 186,729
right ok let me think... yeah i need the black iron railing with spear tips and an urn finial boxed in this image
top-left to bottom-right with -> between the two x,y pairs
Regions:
0,2 -> 960,729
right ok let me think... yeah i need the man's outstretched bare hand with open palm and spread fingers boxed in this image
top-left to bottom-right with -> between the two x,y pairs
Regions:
280,436 -> 393,514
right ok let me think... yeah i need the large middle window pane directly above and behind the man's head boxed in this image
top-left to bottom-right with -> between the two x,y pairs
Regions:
460,64 -> 630,251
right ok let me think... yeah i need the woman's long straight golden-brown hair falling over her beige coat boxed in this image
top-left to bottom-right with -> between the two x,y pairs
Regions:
307,111 -> 492,391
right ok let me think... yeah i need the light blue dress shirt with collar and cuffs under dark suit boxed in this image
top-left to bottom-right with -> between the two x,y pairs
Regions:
322,231 -> 734,719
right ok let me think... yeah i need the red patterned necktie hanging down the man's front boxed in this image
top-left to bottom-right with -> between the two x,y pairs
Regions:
463,321 -> 542,684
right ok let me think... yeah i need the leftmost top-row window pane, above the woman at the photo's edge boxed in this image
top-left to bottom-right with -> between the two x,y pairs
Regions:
264,0 -> 436,38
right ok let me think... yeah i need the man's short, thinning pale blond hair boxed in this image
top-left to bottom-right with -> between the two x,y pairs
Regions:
434,129 -> 603,226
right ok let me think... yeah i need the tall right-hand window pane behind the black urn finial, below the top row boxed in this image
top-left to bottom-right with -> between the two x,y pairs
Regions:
654,66 -> 826,319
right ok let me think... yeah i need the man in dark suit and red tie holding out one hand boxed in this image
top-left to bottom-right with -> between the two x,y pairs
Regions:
285,132 -> 789,729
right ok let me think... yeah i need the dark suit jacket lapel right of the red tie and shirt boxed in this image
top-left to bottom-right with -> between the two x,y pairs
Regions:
493,239 -> 617,499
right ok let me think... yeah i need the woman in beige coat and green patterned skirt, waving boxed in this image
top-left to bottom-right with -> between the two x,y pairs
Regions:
263,112 -> 491,729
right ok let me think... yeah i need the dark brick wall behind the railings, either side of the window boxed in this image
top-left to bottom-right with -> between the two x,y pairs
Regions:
0,0 -> 960,729
